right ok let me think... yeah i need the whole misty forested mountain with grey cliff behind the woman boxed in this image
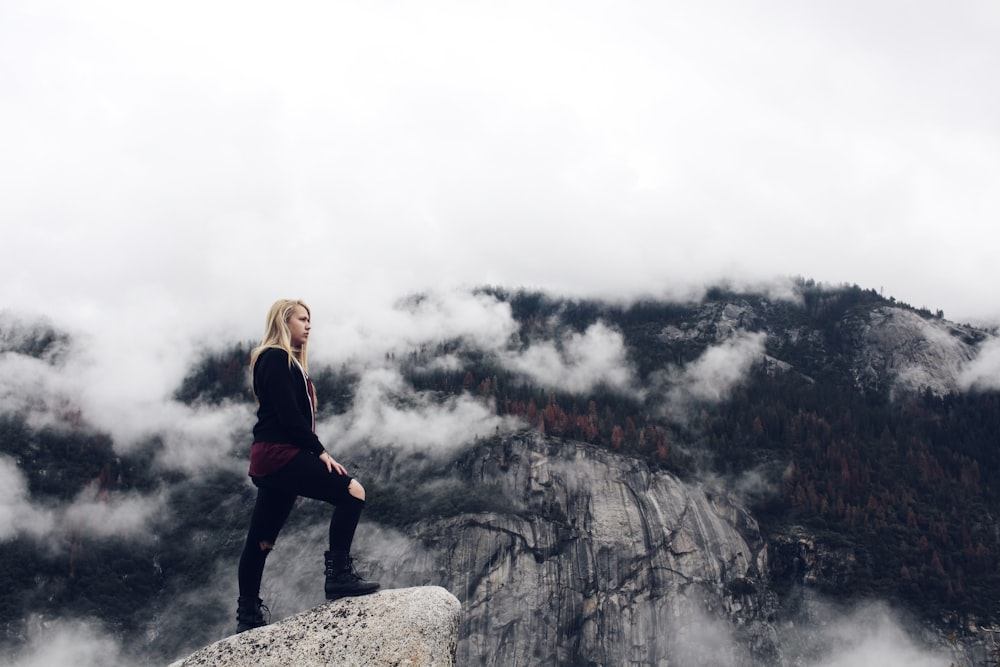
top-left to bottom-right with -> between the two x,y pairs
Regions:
0,281 -> 1000,665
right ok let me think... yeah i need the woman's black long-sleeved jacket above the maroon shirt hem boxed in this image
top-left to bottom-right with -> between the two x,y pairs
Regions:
253,348 -> 324,456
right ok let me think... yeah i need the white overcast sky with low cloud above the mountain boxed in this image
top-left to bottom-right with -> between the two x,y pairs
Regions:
0,0 -> 1000,360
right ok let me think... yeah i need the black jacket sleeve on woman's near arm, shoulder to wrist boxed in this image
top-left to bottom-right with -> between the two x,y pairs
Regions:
254,349 -> 325,456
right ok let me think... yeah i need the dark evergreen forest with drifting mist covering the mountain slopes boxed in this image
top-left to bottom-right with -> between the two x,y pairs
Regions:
0,281 -> 1000,657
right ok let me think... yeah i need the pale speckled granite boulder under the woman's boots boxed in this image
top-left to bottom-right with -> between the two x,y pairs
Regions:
170,586 -> 461,667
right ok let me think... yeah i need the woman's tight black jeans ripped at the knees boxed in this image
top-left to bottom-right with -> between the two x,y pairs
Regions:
239,451 -> 365,598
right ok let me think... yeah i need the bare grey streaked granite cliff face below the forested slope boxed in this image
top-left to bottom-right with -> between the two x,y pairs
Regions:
370,434 -> 776,665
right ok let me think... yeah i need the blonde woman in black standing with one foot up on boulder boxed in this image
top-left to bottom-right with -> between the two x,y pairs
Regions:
236,299 -> 379,632
